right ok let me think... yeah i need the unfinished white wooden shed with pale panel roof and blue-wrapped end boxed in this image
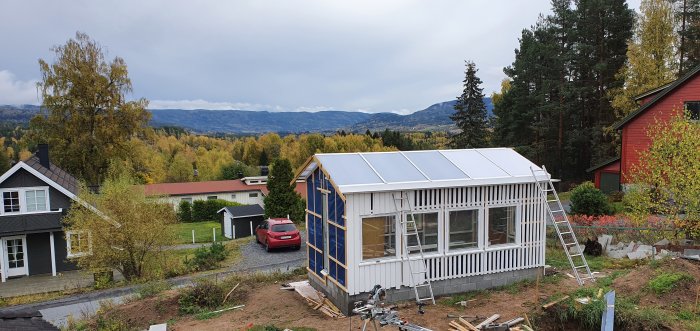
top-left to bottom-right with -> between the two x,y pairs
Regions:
298,148 -> 546,314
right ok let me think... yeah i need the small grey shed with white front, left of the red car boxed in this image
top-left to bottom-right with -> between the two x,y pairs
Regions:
218,204 -> 265,239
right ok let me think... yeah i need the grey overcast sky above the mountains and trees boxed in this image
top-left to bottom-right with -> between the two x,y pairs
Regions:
0,0 -> 639,113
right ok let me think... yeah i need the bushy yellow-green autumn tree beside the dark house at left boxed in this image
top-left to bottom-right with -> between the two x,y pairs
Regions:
63,176 -> 177,280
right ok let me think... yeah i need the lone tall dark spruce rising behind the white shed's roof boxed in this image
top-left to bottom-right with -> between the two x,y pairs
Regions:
450,61 -> 487,148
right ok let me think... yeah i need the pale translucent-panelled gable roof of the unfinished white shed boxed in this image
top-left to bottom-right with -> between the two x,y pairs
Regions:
300,148 -> 541,193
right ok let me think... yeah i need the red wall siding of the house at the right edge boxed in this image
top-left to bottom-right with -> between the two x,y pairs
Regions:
620,75 -> 700,183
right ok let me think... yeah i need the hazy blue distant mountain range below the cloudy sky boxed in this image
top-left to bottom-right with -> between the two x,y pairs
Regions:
0,98 -> 493,134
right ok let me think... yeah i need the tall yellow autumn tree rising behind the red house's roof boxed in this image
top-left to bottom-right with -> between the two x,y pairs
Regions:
609,0 -> 677,118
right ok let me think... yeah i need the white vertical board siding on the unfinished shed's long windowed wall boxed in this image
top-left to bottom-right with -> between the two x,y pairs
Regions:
345,183 -> 545,295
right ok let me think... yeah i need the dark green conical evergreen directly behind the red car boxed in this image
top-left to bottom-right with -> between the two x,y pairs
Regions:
265,159 -> 304,222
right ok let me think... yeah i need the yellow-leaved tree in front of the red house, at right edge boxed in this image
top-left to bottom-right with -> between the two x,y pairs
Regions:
624,115 -> 700,238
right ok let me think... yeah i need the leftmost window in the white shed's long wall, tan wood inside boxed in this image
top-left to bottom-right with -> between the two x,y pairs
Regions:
362,216 -> 396,260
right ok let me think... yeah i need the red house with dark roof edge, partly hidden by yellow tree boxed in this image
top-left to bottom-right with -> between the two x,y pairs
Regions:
588,66 -> 700,192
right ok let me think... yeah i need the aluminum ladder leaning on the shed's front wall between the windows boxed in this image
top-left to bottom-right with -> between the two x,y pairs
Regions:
391,191 -> 435,306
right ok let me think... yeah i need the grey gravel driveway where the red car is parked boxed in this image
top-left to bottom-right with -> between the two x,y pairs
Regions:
231,231 -> 306,271
